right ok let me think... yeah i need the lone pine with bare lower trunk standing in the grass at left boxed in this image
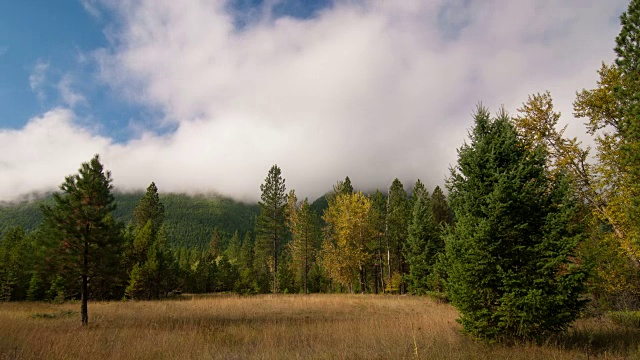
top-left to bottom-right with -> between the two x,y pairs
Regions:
42,155 -> 122,325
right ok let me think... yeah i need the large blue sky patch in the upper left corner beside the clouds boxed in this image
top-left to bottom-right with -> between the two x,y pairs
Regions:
0,0 -> 168,143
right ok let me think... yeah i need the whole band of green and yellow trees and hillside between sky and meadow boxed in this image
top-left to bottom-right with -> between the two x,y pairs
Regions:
0,1 -> 640,348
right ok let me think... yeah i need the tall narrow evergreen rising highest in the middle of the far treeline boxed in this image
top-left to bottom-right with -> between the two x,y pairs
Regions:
255,165 -> 287,292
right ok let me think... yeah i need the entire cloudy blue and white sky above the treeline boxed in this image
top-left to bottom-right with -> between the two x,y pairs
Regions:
0,0 -> 628,201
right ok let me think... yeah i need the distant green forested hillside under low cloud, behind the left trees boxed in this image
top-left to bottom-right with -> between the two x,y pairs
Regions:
0,192 -> 258,247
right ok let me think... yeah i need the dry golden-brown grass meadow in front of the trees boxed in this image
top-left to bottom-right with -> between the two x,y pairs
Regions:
0,295 -> 640,359
